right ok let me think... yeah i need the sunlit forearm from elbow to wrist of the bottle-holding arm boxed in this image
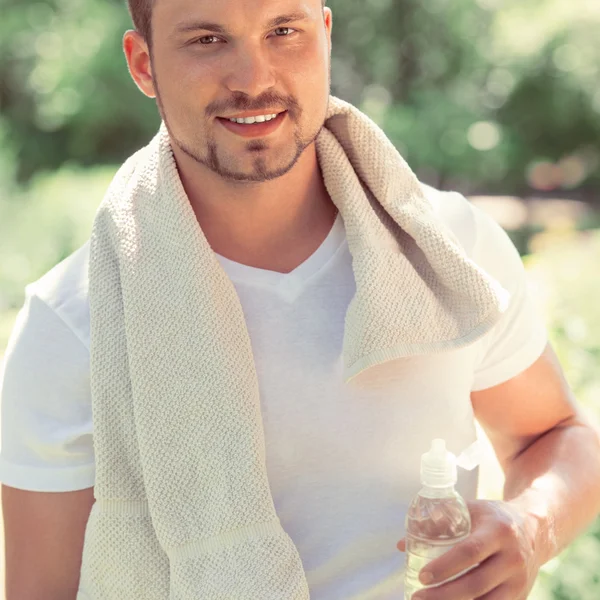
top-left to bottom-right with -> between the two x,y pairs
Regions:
504,421 -> 600,565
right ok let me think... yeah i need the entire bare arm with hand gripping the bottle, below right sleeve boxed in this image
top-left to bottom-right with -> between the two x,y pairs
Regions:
398,346 -> 600,600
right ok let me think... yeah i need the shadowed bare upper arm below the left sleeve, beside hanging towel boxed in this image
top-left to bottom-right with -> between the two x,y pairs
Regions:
0,485 -> 94,600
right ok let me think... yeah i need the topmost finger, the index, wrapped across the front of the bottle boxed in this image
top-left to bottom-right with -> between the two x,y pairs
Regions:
419,528 -> 501,585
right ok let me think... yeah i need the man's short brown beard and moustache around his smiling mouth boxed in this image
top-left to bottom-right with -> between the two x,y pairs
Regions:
155,82 -> 326,183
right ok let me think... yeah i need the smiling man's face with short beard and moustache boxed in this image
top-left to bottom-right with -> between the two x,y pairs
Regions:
151,0 -> 331,181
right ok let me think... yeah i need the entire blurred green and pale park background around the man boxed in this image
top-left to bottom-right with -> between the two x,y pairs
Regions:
0,0 -> 600,600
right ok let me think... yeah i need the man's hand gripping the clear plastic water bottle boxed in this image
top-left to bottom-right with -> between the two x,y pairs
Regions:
397,500 -> 541,600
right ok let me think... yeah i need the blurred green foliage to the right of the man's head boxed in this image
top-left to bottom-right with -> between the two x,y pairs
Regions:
329,0 -> 600,195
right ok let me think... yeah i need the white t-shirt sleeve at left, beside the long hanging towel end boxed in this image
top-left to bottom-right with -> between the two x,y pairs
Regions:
0,291 -> 95,492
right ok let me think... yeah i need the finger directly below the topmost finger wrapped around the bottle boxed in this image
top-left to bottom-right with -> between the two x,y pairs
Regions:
414,554 -> 514,600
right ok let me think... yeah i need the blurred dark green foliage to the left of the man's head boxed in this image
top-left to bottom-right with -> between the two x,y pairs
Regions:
0,0 -> 158,181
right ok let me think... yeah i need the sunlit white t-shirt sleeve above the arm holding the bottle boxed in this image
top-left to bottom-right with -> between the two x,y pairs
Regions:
472,206 -> 548,391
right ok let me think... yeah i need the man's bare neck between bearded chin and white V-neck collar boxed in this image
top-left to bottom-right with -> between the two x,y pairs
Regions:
173,143 -> 337,273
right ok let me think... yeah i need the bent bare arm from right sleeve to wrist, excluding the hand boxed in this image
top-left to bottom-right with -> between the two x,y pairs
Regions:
472,346 -> 600,564
